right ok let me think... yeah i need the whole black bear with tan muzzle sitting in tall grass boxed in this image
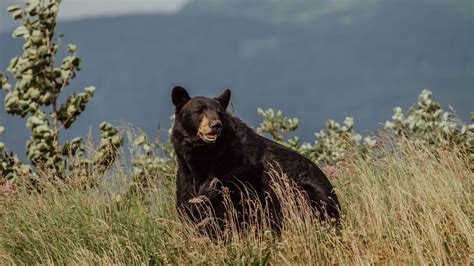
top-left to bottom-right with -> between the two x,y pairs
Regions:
171,86 -> 339,232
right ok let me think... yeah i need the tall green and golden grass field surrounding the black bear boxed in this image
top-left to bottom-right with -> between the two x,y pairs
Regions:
0,137 -> 474,265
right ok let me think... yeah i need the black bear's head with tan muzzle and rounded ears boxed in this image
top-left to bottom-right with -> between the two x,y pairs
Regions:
171,86 -> 230,144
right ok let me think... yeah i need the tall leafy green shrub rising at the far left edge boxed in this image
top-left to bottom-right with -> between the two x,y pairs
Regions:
0,0 -> 122,178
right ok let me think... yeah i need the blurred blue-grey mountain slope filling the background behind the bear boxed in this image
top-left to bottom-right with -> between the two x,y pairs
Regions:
0,0 -> 474,158
